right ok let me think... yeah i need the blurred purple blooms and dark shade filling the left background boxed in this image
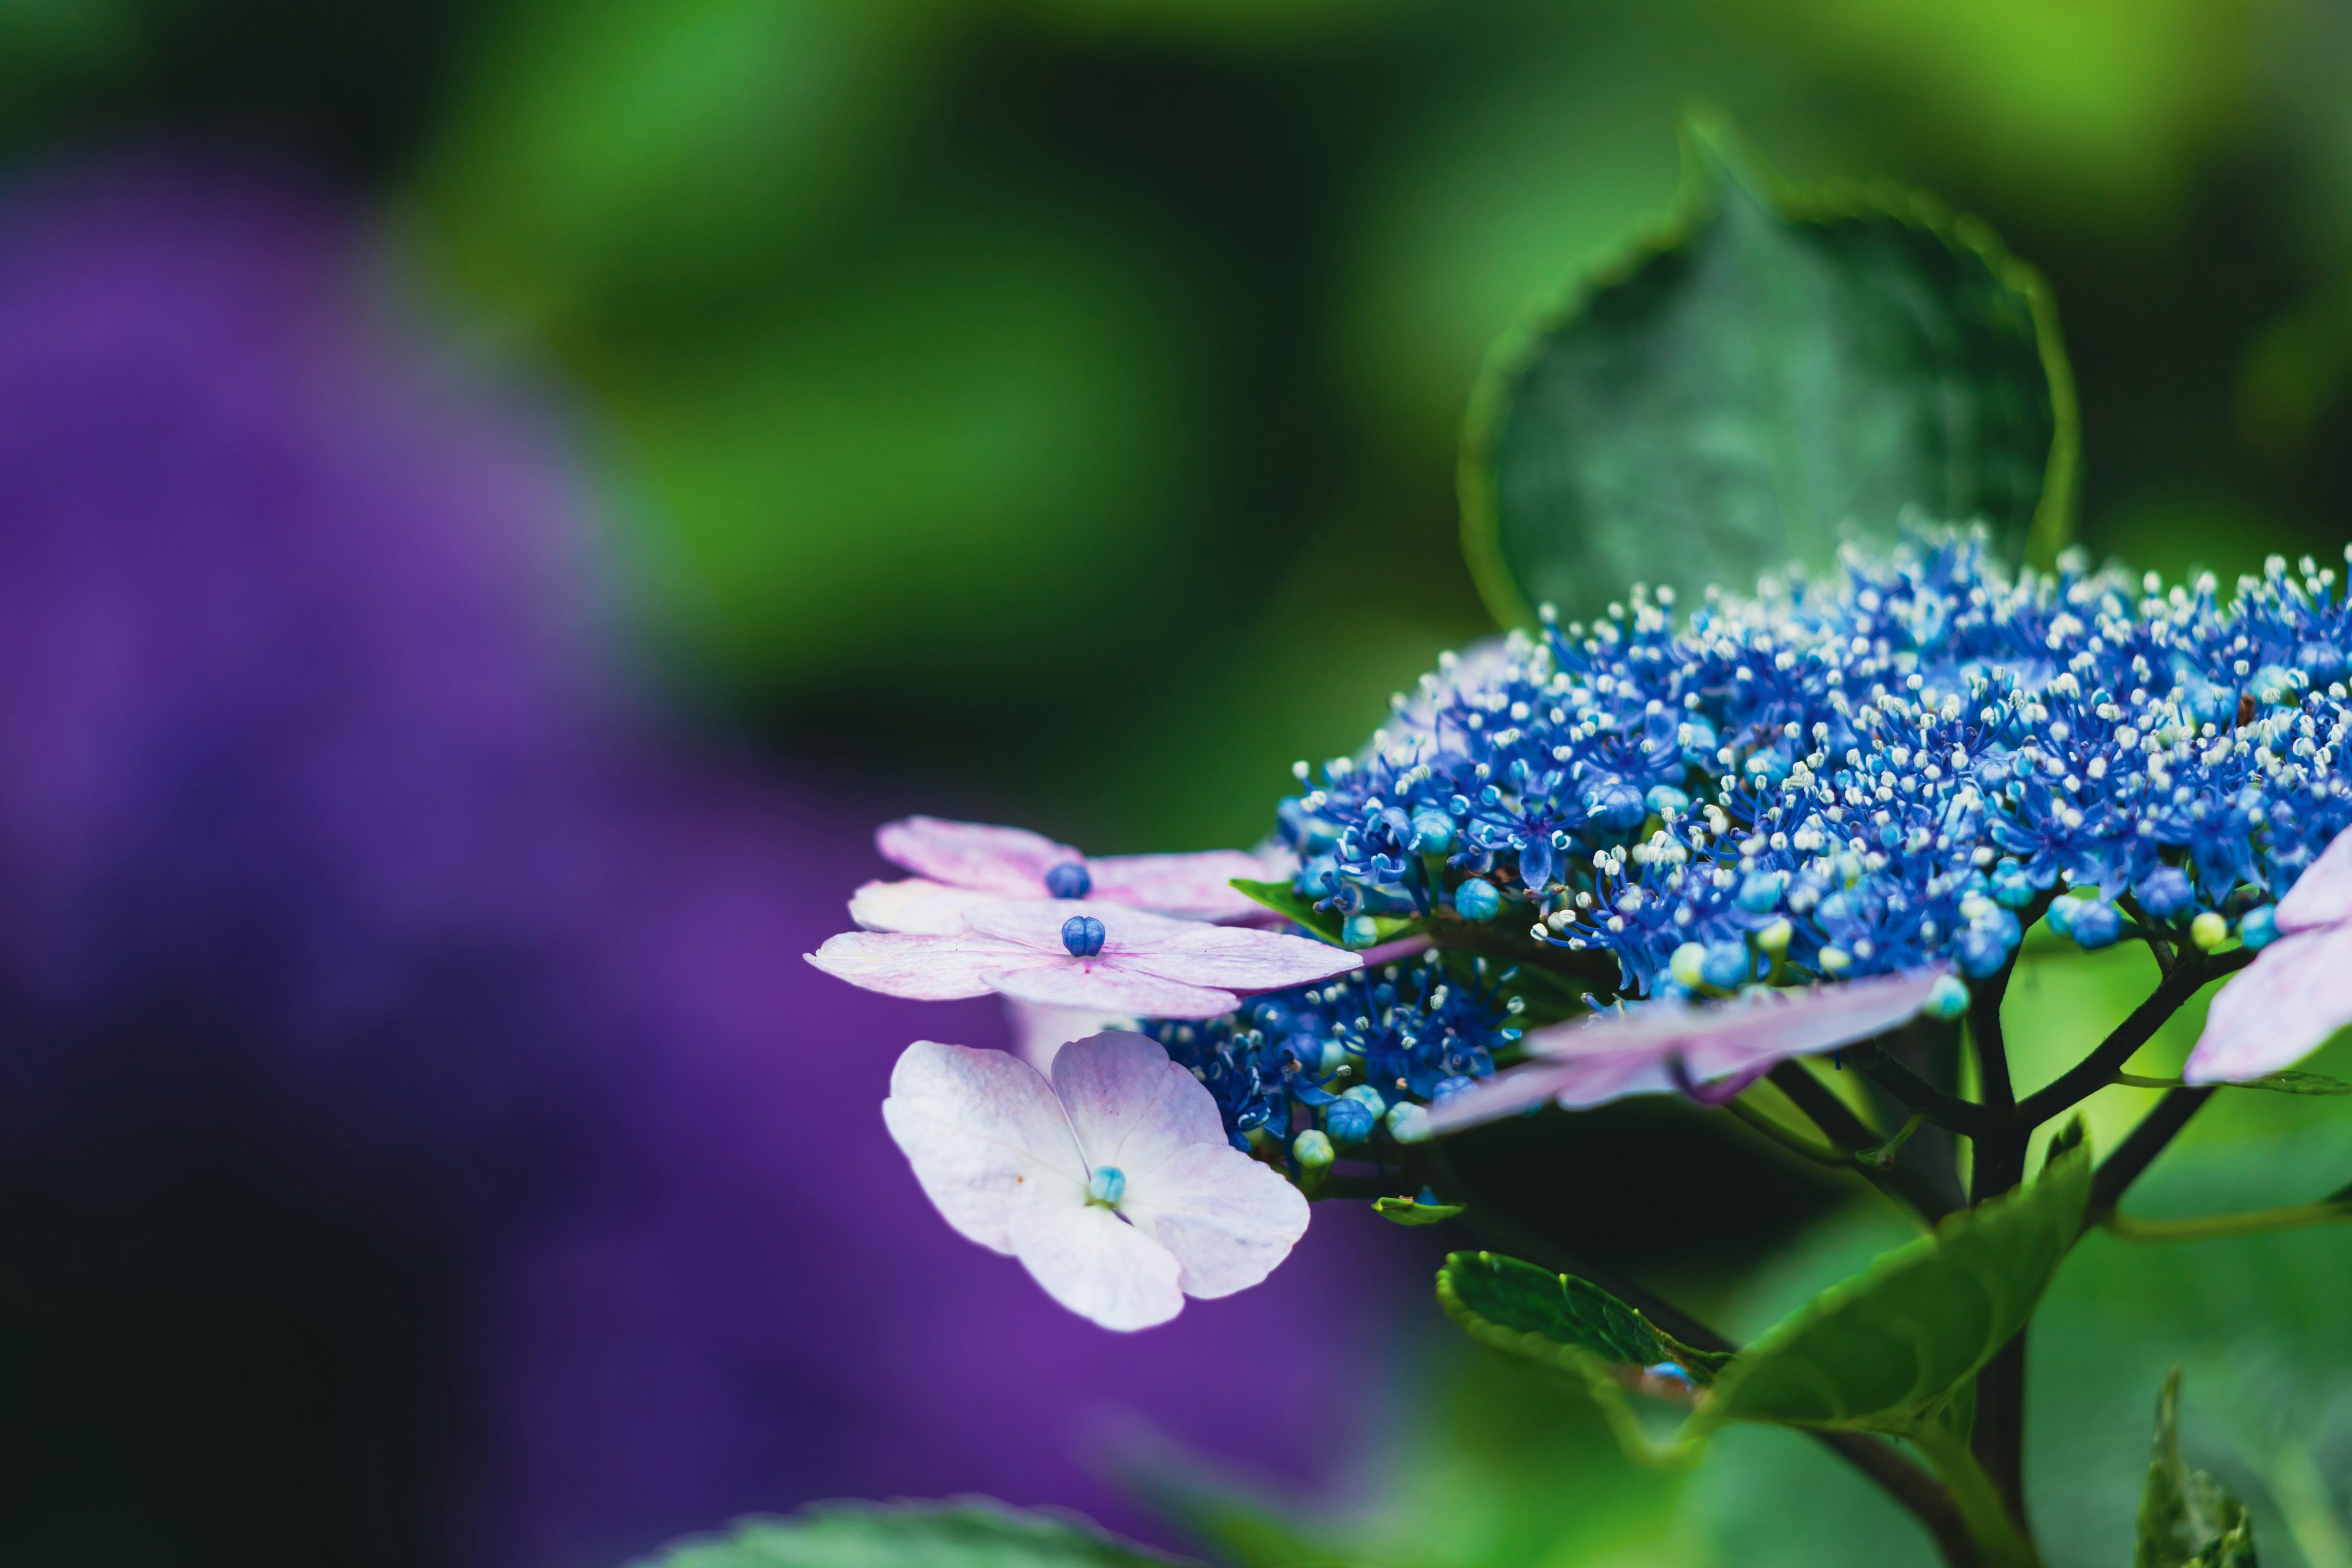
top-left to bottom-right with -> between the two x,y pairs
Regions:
0,155 -> 1423,1568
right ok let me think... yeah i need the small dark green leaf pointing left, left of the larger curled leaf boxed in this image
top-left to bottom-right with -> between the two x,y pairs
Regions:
1437,1253 -> 1731,1385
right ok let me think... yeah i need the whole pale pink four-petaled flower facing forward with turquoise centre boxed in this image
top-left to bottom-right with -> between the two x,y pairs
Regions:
882,1035 -> 1308,1330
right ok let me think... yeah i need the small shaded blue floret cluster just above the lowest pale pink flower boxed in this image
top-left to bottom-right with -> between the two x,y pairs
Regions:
1140,952 -> 1520,1147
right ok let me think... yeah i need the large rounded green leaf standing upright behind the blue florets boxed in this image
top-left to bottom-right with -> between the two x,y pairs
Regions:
1461,111 -> 2077,625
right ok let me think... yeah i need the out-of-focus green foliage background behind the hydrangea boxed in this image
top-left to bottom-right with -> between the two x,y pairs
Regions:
0,0 -> 2352,1568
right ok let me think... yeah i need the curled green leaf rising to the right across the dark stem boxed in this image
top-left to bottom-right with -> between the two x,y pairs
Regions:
1691,1128 -> 2091,1434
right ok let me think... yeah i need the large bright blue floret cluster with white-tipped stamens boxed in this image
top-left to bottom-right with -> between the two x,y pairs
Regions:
1282,536 -> 2352,997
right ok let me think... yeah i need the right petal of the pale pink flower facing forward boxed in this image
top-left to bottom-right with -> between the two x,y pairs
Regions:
1115,1142 -> 1308,1300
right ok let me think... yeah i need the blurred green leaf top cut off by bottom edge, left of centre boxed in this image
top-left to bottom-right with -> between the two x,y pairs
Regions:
642,1498 -> 1183,1568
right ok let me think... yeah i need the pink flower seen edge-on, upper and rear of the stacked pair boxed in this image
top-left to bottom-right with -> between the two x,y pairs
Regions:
849,816 -> 1298,936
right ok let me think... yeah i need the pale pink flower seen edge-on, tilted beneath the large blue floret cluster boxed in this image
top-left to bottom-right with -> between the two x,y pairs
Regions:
1423,966 -> 1966,1133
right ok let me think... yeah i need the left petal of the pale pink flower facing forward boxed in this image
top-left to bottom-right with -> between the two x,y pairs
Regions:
882,1039 -> 1087,1253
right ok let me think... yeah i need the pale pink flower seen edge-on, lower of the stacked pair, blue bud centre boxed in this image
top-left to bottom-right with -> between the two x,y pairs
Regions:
807,898 -> 1362,1018
